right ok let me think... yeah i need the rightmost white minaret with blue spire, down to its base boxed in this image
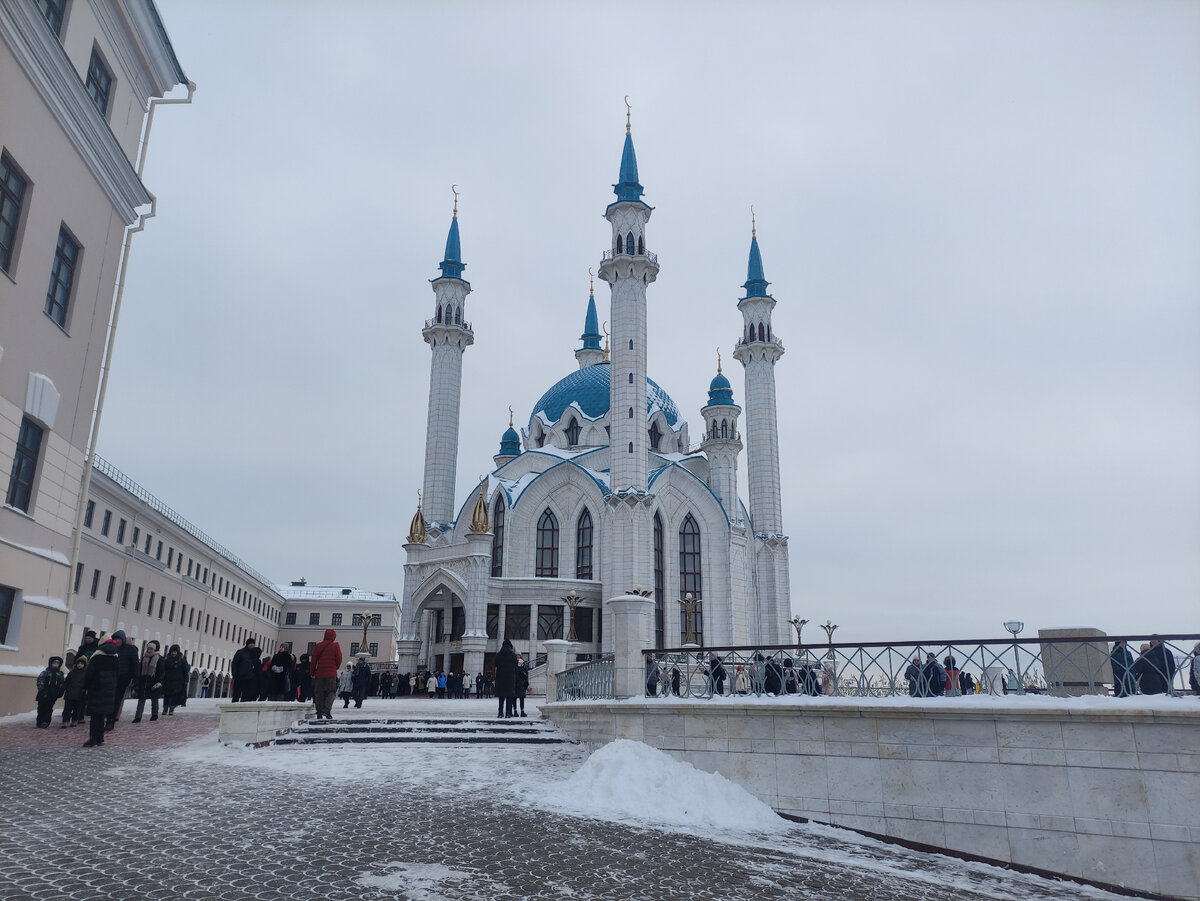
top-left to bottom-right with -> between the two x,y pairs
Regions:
733,218 -> 791,643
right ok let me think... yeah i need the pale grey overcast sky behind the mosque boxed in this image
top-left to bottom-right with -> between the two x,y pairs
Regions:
100,0 -> 1200,641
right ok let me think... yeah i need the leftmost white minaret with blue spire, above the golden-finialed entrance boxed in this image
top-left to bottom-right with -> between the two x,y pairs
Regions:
421,191 -> 475,528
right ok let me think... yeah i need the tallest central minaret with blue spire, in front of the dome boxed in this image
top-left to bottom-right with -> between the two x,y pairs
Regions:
600,104 -> 659,493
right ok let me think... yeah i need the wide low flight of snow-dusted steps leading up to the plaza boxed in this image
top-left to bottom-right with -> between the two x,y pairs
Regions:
275,717 -> 566,747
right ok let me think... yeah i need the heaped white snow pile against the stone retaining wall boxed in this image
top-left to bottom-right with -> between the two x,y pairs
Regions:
538,739 -> 781,833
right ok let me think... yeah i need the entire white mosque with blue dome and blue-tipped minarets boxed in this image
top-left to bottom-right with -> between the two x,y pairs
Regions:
398,114 -> 791,673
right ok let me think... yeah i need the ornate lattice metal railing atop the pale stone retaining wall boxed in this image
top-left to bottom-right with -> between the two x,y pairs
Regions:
648,630 -> 1200,697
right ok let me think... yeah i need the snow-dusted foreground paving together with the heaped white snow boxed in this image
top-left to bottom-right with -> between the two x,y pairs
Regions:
0,699 -> 1161,901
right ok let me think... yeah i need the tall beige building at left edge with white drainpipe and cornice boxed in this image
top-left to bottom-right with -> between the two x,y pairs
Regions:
0,0 -> 187,713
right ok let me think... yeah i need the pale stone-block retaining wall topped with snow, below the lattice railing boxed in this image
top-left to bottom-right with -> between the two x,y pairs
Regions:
541,698 -> 1200,899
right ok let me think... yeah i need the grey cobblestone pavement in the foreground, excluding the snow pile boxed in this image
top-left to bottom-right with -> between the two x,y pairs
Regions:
0,707 -> 1132,901
